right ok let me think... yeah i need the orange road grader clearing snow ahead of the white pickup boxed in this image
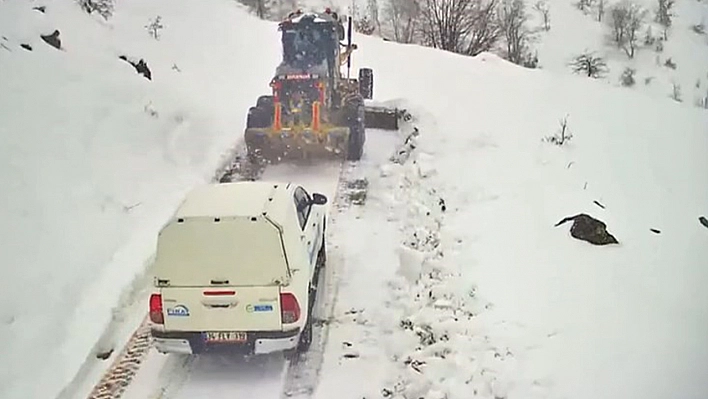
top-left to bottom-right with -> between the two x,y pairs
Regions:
244,9 -> 400,163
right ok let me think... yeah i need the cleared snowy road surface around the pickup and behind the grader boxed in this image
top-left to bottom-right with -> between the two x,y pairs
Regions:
88,130 -> 400,399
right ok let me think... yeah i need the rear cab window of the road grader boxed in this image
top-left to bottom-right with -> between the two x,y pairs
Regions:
283,26 -> 328,68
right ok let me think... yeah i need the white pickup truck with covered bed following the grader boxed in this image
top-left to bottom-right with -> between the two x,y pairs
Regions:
149,181 -> 327,354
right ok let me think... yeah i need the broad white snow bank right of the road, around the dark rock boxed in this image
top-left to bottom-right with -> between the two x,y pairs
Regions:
318,32 -> 708,399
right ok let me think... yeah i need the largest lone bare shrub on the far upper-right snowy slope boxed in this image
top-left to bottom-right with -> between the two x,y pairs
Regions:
608,0 -> 647,58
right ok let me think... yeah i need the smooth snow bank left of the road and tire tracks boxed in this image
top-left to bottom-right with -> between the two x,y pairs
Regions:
0,0 -> 279,399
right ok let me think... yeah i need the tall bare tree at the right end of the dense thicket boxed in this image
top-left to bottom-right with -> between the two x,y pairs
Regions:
499,0 -> 531,65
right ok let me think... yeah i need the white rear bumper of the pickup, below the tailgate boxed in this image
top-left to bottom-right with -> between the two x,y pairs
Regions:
151,328 -> 300,355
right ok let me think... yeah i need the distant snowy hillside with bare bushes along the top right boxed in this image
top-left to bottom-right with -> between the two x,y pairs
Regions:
306,0 -> 708,109
